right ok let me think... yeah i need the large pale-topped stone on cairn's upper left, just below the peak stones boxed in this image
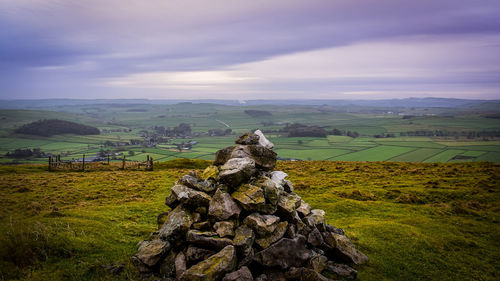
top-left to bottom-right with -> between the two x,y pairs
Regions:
219,157 -> 256,187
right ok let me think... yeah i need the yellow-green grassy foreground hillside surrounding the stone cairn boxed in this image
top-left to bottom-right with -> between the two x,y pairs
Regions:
0,160 -> 500,280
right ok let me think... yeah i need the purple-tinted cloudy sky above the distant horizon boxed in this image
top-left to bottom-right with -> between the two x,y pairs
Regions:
0,0 -> 500,100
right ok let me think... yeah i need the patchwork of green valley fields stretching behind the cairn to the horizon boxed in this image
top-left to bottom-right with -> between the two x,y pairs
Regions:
0,103 -> 500,163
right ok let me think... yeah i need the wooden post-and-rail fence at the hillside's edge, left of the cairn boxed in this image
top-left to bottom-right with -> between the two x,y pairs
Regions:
48,154 -> 153,172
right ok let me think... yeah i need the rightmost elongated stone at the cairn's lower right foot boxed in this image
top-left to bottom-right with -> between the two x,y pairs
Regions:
323,232 -> 369,264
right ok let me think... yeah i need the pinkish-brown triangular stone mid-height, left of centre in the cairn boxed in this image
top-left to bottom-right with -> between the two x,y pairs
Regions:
208,189 -> 241,221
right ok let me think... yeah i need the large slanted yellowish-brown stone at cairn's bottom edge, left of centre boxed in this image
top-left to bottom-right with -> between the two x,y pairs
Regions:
180,245 -> 237,281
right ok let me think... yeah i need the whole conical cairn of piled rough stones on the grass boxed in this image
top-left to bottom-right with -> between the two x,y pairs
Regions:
132,131 -> 368,281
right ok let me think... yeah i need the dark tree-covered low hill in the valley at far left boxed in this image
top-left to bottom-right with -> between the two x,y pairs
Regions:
15,119 -> 100,137
